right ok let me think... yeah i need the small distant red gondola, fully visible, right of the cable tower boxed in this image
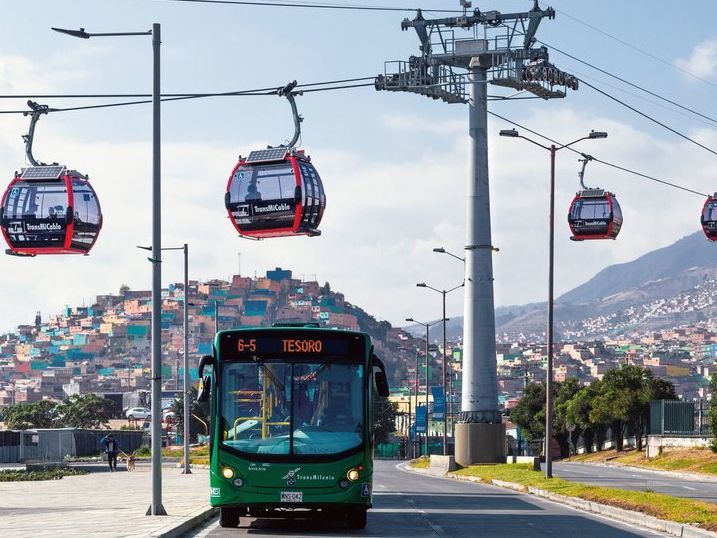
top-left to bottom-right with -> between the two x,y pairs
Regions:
568,155 -> 622,241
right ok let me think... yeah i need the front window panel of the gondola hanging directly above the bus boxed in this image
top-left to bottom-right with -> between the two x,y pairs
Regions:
229,163 -> 296,231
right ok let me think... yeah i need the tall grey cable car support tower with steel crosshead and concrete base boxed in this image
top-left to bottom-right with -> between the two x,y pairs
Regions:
375,0 -> 578,465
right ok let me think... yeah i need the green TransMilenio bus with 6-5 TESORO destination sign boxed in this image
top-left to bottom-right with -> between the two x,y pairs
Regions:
198,324 -> 388,529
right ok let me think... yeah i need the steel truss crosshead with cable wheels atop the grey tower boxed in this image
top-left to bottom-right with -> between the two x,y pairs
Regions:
375,0 -> 578,103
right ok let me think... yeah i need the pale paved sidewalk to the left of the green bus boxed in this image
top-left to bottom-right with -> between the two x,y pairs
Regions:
0,465 -> 212,537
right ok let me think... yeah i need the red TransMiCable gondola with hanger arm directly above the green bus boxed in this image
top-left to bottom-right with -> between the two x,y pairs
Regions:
224,81 -> 326,239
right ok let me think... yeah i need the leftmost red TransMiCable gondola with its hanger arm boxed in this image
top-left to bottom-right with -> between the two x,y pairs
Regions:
0,102 -> 102,256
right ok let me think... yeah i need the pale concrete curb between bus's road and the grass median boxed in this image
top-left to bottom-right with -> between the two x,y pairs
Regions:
405,465 -> 717,538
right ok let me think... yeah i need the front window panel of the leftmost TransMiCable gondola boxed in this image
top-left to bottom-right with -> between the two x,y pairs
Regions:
2,181 -> 67,248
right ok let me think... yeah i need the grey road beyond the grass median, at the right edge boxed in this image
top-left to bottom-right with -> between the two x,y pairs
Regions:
553,462 -> 717,503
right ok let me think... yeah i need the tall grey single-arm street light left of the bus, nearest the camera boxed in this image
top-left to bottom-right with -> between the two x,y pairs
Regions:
52,23 -> 167,516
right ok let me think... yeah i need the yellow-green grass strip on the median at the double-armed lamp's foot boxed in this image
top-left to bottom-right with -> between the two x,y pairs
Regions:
451,465 -> 717,531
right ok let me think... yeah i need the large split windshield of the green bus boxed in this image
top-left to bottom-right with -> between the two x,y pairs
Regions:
221,359 -> 365,456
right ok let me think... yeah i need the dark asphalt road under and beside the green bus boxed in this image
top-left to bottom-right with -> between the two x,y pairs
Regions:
193,461 -> 664,538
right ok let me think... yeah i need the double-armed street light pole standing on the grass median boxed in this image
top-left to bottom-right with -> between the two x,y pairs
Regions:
500,129 -> 607,478
